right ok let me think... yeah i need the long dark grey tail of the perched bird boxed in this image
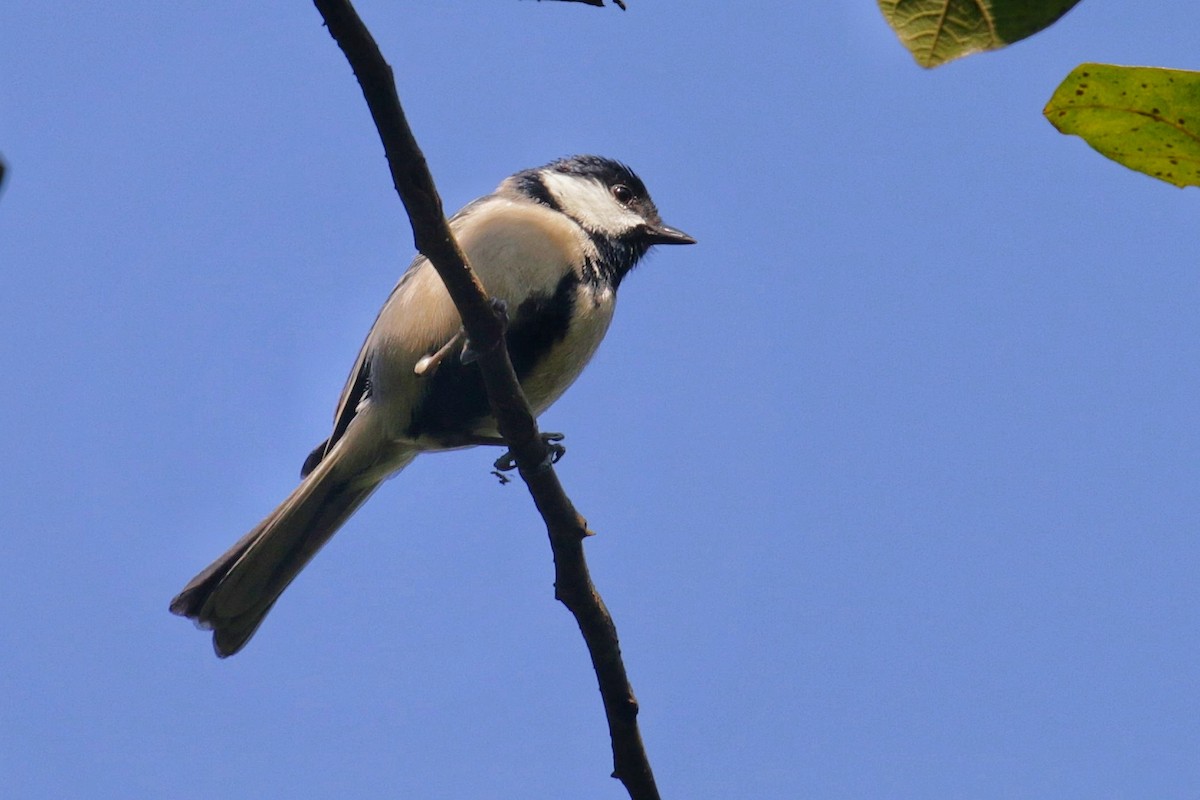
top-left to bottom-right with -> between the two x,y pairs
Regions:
170,450 -> 412,658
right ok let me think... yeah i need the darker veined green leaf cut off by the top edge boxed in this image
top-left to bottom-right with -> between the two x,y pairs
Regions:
878,0 -> 1079,67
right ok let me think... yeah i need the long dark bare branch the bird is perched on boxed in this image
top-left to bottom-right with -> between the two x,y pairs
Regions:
313,0 -> 659,800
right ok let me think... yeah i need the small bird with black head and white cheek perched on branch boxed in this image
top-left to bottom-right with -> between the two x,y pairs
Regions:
170,155 -> 696,658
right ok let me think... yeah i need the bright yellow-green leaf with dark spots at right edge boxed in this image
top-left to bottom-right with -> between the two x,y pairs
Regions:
1042,64 -> 1200,186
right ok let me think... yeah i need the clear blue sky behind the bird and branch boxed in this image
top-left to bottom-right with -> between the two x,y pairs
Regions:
0,0 -> 1200,800
